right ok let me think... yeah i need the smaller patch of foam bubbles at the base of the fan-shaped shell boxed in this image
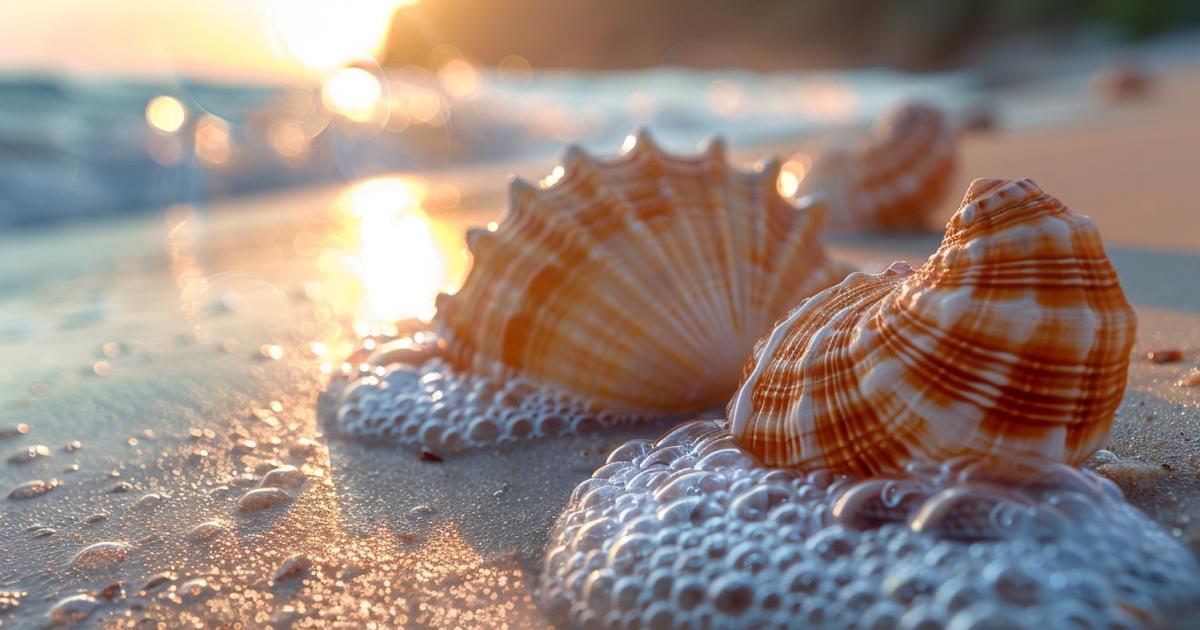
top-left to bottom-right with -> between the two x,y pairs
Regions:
323,331 -> 629,452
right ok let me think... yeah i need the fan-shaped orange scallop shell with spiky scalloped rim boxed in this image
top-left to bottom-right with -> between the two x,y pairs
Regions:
436,133 -> 846,416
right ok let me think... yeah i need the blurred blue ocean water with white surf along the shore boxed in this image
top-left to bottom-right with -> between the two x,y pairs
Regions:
0,68 -> 971,227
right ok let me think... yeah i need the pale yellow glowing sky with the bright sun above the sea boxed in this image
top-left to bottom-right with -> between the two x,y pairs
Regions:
0,0 -> 415,82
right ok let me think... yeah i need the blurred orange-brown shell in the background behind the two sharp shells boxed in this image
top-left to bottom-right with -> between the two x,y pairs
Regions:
797,104 -> 955,232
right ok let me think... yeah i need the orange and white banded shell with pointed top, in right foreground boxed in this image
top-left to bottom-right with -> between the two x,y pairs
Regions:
727,179 -> 1136,475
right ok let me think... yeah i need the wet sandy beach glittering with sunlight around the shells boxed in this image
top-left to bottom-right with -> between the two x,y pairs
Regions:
0,66 -> 1200,628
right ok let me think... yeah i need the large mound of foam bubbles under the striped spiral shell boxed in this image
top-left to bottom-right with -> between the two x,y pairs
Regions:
540,420 -> 1200,629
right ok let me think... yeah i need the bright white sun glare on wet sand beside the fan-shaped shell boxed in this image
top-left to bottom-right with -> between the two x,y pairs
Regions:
341,176 -> 467,326
